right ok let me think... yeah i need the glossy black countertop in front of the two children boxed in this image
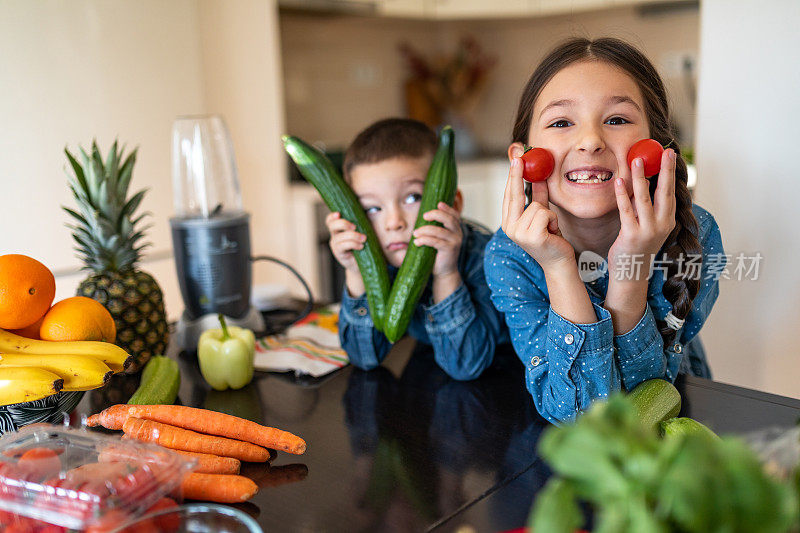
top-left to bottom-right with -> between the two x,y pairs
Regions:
78,332 -> 800,532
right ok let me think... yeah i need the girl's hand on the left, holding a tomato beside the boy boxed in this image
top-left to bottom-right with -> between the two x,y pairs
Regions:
502,157 -> 575,271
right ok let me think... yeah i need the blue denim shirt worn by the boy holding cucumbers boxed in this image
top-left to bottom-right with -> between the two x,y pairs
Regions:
339,221 -> 508,380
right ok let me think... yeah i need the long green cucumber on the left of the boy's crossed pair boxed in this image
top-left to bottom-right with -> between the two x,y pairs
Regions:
283,135 -> 389,331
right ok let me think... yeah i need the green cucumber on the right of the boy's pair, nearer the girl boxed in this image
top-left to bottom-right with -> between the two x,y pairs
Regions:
383,126 -> 458,342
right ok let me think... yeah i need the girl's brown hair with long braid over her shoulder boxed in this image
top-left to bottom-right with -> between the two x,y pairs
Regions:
512,37 -> 703,347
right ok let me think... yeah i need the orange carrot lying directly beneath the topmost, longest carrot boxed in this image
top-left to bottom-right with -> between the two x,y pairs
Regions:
122,417 -> 269,462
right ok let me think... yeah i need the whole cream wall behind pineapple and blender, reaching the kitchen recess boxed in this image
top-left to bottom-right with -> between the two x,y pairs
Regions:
0,0 -> 291,318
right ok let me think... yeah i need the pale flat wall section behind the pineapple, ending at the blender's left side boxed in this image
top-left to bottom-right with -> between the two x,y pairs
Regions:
0,0 -> 206,314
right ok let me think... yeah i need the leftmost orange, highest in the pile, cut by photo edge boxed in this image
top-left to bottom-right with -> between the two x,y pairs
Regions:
0,254 -> 56,329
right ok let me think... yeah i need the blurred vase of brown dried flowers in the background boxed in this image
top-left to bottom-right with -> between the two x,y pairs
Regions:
399,36 -> 496,156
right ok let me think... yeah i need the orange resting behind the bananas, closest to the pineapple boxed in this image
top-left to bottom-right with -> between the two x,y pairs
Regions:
39,296 -> 117,342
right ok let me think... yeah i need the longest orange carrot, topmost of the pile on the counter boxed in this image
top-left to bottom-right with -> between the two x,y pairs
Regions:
128,405 -> 306,454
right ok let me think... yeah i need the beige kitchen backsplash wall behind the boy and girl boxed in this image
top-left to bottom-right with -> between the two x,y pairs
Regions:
280,5 -> 700,154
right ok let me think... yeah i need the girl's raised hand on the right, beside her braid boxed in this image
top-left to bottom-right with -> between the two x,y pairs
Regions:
608,148 -> 675,280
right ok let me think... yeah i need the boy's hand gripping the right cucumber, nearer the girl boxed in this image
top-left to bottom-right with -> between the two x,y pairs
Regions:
414,202 -> 463,276
